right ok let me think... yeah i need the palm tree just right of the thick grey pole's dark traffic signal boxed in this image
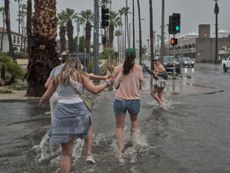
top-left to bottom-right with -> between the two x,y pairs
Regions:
108,11 -> 121,48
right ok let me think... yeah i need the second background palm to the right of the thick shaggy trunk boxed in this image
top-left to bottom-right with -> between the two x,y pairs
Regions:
65,8 -> 77,53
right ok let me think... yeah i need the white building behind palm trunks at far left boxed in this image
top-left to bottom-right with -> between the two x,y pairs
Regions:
0,27 -> 26,53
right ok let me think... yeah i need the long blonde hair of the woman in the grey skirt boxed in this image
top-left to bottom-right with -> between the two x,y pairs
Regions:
55,57 -> 82,86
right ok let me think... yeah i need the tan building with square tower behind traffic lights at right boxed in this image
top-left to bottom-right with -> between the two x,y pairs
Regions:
157,24 -> 230,62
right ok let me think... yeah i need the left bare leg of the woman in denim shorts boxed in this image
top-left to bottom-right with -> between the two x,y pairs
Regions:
116,114 -> 125,152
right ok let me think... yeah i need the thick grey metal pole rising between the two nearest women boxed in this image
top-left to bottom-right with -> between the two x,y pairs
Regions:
93,0 -> 99,75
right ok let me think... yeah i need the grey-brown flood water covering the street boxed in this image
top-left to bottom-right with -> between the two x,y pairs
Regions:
0,64 -> 230,173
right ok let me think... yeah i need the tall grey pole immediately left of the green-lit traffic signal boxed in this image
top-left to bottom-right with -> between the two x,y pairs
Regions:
160,0 -> 165,57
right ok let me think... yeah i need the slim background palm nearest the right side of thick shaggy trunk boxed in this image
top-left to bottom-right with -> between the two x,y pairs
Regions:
58,10 -> 66,52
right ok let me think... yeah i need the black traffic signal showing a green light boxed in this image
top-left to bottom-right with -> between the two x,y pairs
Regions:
168,13 -> 181,34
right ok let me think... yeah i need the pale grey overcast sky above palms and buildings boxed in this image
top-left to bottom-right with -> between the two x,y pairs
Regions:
0,0 -> 230,45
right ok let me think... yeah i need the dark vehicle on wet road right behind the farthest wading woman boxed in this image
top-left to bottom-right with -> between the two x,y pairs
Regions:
161,55 -> 180,74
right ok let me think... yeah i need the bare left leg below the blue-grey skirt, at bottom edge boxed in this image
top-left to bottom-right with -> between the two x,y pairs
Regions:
60,140 -> 73,173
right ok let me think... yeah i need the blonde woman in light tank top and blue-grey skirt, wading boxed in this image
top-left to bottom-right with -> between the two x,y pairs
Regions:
39,58 -> 112,172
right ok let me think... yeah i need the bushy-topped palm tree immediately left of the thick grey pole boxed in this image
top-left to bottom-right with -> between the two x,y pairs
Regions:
80,10 -> 93,53
